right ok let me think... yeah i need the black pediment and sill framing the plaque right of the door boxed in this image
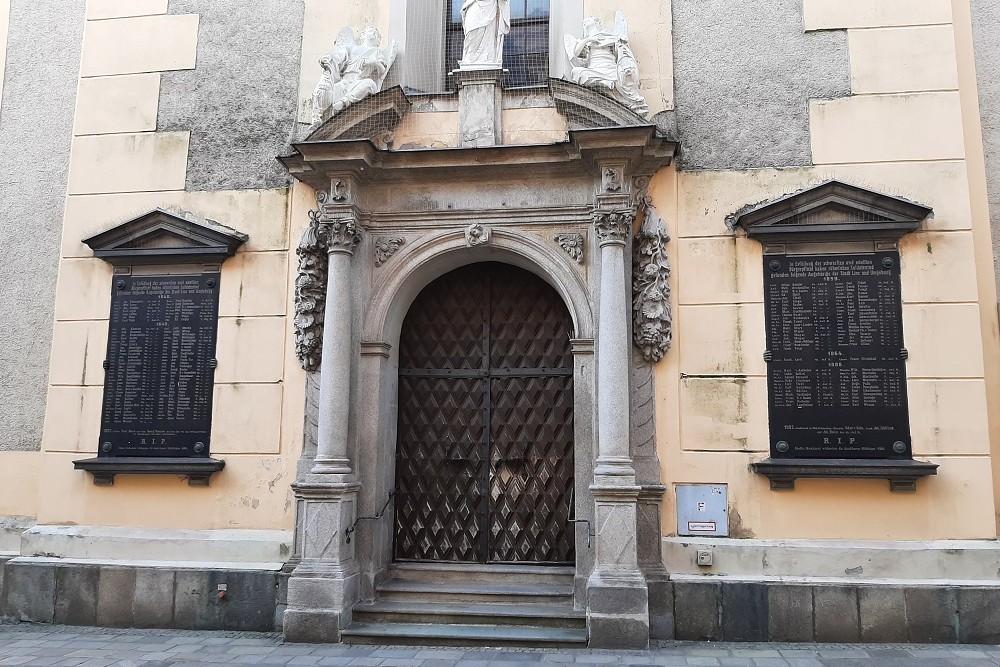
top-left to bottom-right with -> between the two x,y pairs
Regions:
726,181 -> 938,492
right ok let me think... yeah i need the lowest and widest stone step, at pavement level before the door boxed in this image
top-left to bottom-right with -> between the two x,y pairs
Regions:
341,621 -> 587,648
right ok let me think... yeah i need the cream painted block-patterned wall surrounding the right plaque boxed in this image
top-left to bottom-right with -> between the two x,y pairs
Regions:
652,0 -> 997,540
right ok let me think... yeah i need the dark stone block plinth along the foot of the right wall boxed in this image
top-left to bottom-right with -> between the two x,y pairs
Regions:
650,580 -> 1000,644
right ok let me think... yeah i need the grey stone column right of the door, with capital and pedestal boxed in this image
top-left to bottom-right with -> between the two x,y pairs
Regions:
587,210 -> 649,648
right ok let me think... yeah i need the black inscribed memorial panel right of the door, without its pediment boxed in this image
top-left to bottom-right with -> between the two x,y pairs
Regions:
764,251 -> 911,459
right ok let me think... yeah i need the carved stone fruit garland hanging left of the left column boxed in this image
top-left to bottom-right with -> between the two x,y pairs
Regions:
295,201 -> 329,371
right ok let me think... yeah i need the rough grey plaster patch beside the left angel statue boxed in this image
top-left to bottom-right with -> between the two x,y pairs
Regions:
157,0 -> 304,190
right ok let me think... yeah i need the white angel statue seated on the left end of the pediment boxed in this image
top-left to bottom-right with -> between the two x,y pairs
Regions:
312,26 -> 396,125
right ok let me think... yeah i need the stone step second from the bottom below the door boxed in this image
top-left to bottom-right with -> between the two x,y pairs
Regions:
354,600 -> 587,630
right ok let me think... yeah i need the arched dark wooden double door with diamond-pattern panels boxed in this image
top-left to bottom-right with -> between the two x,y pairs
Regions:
394,262 -> 575,564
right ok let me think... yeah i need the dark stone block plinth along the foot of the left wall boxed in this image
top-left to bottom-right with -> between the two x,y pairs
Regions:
0,558 -> 287,632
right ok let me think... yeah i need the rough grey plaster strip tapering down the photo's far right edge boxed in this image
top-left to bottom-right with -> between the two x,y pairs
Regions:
972,0 -> 1000,286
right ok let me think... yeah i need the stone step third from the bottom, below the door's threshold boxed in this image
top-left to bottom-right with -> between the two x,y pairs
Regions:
377,579 -> 573,608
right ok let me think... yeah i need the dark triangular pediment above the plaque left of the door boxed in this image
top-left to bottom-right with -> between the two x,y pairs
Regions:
83,209 -> 249,265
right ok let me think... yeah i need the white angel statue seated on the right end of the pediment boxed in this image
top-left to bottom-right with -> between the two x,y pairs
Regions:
566,11 -> 649,116
